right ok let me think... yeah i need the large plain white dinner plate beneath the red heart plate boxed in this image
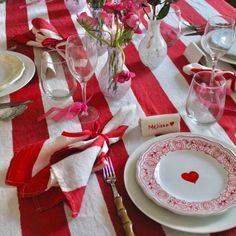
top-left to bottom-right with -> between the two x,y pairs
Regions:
124,133 -> 236,233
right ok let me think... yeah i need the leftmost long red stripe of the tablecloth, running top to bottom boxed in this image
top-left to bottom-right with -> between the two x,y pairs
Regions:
6,0 -> 69,236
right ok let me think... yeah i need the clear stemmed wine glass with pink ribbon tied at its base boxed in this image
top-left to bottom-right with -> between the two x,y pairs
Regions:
66,33 -> 99,123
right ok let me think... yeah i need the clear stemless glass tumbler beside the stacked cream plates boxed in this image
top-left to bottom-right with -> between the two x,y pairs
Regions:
40,49 -> 77,100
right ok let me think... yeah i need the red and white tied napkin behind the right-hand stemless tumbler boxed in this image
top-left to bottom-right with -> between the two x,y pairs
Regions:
183,63 -> 236,92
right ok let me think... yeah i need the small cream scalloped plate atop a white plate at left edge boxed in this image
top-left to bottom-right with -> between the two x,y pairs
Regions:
0,51 -> 25,89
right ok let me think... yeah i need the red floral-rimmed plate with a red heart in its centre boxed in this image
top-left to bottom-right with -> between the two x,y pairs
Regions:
136,135 -> 236,216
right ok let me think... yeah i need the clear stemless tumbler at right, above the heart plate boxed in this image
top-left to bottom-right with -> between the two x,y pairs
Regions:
186,71 -> 226,125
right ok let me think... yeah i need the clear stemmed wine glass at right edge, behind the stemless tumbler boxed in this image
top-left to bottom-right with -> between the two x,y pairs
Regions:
202,15 -> 235,78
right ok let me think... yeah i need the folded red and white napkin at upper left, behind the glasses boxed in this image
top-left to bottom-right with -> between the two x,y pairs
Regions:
14,18 -> 66,57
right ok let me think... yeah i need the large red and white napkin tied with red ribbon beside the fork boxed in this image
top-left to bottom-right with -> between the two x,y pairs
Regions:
6,105 -> 135,217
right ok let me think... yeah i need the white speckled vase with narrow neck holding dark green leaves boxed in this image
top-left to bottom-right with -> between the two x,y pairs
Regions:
138,20 -> 167,69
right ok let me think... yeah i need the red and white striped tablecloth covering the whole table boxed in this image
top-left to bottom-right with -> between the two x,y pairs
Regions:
0,0 -> 236,236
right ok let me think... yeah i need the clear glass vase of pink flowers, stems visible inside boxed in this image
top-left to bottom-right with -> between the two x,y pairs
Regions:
98,47 -> 131,100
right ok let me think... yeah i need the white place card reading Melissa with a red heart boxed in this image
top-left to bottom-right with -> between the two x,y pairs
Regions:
140,113 -> 180,136
